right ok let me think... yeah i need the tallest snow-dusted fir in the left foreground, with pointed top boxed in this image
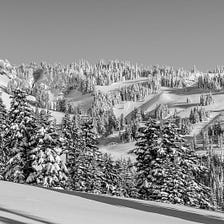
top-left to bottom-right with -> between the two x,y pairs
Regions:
3,89 -> 37,182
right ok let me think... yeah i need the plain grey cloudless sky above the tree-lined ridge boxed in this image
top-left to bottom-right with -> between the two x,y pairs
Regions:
0,0 -> 224,70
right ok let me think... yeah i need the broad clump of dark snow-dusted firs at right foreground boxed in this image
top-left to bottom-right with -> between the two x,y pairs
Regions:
134,120 -> 212,208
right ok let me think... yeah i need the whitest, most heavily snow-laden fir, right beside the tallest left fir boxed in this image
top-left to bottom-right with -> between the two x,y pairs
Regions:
26,111 -> 68,188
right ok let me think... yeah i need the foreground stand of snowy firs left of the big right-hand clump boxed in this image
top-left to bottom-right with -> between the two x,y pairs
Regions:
0,90 -> 136,197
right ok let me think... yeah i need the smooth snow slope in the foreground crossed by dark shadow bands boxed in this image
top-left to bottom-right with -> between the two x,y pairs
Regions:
0,181 -> 224,224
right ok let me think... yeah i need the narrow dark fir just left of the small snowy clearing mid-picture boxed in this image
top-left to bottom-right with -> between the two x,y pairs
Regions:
71,121 -> 102,193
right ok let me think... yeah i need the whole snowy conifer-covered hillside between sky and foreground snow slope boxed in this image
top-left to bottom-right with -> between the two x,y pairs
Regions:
0,60 -> 224,211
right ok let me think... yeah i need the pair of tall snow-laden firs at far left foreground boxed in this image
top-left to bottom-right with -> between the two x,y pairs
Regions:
2,90 -> 66,187
